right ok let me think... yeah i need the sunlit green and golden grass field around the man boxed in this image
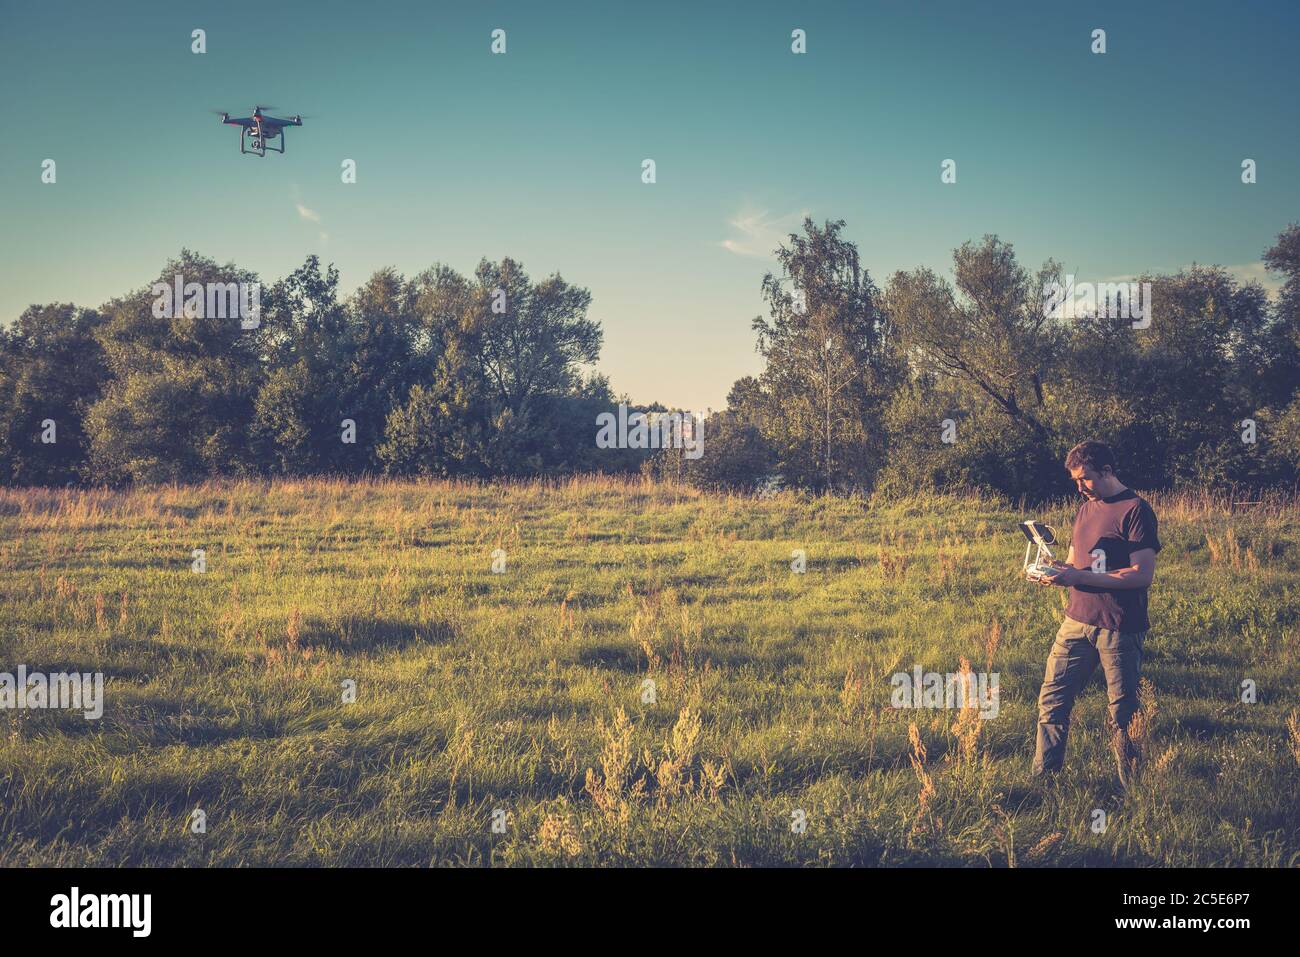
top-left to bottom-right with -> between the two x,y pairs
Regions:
0,479 -> 1300,867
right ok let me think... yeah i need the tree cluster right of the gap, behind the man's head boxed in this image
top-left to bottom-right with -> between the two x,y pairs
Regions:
670,220 -> 1300,498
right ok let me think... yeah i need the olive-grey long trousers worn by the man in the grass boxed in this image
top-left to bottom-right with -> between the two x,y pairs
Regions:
1034,618 -> 1147,774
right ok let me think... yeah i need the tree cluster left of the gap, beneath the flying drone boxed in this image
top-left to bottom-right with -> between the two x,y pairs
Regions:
0,250 -> 650,485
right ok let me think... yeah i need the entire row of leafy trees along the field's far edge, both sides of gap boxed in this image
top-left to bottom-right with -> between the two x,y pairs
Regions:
0,220 -> 1300,497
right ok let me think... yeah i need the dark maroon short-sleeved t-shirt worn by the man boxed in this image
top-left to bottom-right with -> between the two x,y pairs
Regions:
1065,489 -> 1161,632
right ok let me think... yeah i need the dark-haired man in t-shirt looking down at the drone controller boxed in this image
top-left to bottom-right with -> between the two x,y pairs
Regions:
1034,441 -> 1161,787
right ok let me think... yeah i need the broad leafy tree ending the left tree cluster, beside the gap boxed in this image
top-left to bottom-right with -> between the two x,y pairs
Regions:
378,257 -> 611,476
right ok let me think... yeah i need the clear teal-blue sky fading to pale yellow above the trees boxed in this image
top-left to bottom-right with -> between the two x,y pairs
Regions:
0,0 -> 1300,408
